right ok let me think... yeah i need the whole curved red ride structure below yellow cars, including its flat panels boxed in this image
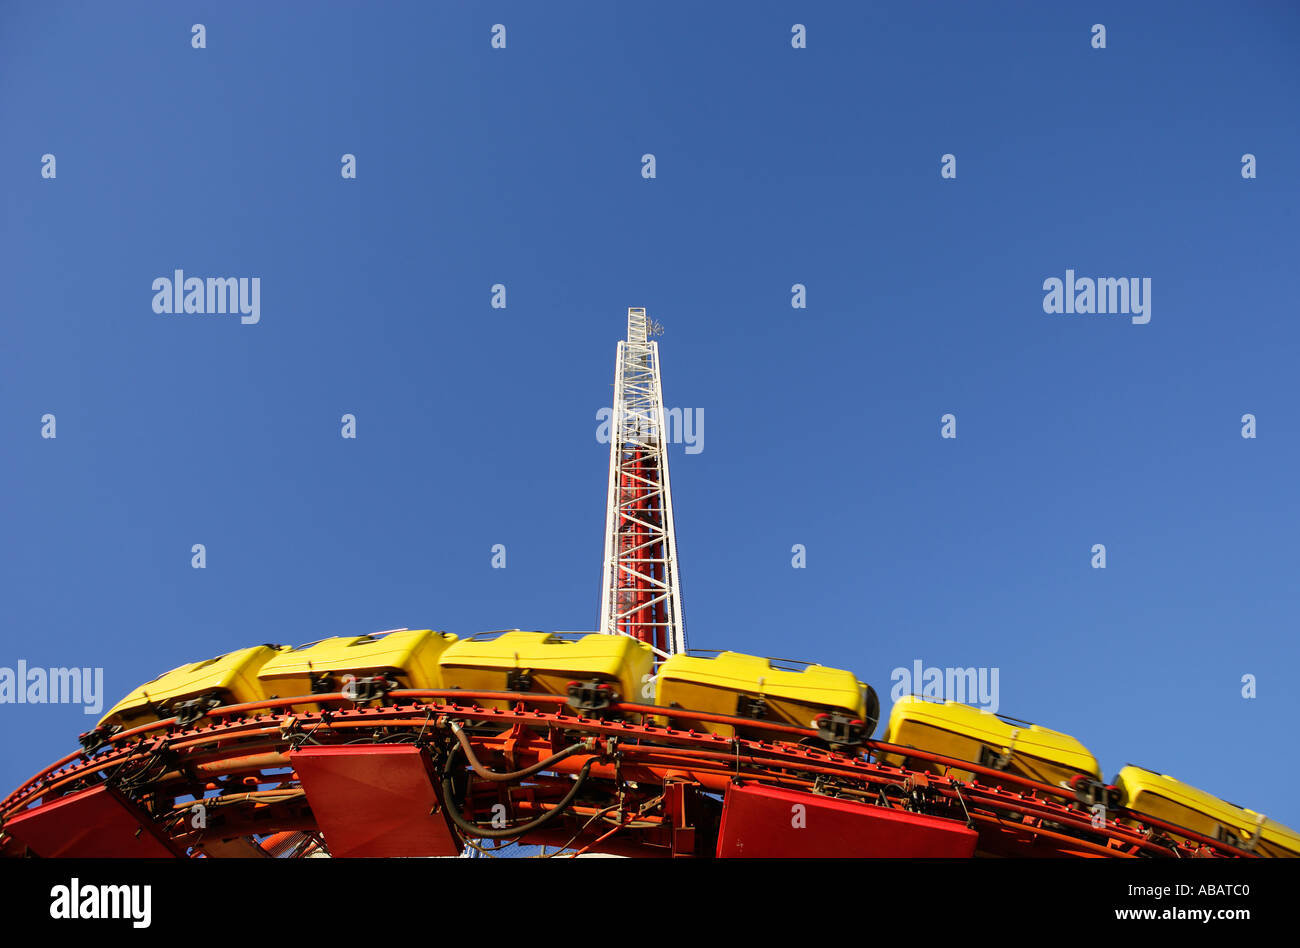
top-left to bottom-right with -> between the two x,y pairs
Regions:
0,691 -> 1253,858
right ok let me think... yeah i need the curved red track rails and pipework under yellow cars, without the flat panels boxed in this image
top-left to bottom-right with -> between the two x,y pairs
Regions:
0,689 -> 1255,858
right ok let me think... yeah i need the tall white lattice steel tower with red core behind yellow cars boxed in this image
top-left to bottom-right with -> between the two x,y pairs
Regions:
599,307 -> 686,658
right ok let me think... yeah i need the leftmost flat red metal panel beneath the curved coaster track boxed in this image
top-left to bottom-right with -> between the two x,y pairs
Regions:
4,784 -> 181,860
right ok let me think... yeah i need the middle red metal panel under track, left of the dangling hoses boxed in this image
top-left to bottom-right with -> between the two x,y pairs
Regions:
289,744 -> 460,857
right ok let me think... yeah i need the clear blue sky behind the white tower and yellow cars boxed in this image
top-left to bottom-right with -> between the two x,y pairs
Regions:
0,3 -> 1300,826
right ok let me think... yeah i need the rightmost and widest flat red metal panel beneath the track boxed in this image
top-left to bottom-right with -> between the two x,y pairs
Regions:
718,783 -> 979,858
